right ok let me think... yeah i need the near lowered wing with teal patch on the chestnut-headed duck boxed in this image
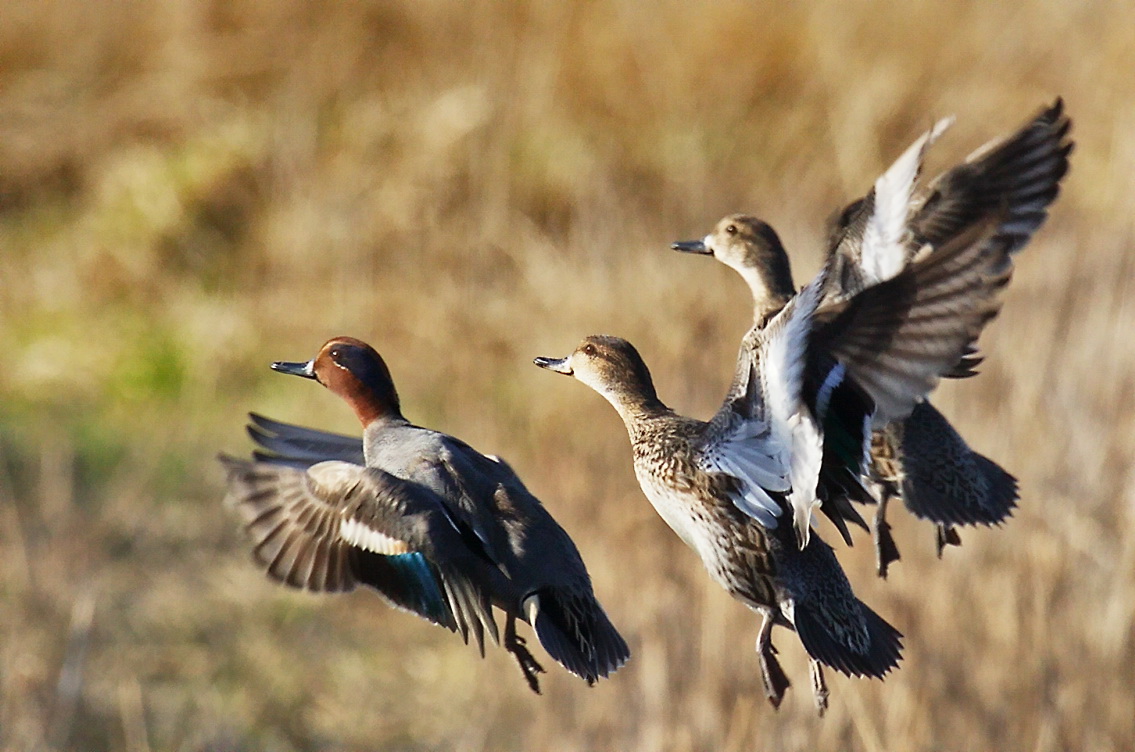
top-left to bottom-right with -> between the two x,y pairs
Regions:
220,456 -> 506,653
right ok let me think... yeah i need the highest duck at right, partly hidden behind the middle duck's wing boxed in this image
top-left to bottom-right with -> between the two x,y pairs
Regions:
673,100 -> 1071,576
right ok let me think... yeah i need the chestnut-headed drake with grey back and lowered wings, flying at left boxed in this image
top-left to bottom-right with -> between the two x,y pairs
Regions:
222,337 -> 630,692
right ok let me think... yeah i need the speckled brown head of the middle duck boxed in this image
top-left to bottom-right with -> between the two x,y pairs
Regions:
532,335 -> 666,419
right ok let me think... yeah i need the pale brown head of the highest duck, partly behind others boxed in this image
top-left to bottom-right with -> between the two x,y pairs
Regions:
670,214 -> 796,311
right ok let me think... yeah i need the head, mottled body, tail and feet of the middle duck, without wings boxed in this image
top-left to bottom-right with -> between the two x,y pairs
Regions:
536,336 -> 901,711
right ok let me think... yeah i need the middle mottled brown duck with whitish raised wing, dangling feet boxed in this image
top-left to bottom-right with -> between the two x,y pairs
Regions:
536,306 -> 902,712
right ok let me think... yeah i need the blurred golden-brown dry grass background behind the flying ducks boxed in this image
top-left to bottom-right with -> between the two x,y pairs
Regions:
0,0 -> 1135,752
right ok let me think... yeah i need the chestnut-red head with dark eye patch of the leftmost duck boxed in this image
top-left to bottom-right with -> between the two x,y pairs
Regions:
272,337 -> 402,426
